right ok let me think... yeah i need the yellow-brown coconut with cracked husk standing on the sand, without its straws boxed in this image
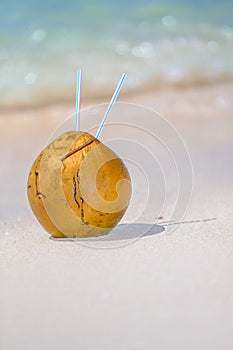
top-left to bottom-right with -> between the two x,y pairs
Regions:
28,131 -> 131,238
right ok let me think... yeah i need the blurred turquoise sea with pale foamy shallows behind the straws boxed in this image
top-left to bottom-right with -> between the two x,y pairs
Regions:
0,0 -> 233,107
